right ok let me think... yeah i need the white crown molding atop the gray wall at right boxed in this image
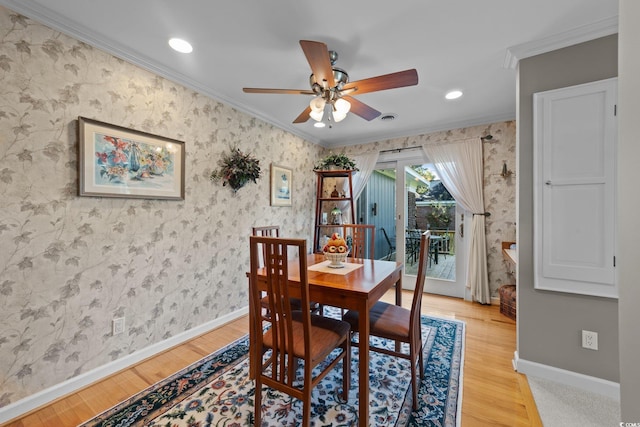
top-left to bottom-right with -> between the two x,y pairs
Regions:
503,15 -> 618,69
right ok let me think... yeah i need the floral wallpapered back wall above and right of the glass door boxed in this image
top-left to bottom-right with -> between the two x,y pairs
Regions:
338,121 -> 516,298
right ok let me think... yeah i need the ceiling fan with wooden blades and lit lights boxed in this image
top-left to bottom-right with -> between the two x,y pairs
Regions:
242,40 -> 418,123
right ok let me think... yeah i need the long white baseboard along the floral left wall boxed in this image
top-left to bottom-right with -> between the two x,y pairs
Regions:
0,307 -> 249,424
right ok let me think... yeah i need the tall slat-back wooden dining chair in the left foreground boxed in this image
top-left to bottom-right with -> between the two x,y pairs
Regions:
249,236 -> 351,426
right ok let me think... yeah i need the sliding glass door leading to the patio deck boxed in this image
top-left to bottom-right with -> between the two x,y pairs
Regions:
358,150 -> 469,298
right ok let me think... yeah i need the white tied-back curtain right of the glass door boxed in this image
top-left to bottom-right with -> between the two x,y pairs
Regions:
422,138 -> 491,304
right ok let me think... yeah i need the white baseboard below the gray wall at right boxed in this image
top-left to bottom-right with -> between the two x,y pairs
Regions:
513,351 -> 620,402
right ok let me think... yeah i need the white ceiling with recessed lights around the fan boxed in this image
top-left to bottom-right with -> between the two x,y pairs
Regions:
0,0 -> 618,147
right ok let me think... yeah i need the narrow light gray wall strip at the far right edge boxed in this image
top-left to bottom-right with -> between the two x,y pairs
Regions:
617,0 -> 640,422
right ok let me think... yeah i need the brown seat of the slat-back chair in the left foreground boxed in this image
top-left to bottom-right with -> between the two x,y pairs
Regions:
264,311 -> 350,366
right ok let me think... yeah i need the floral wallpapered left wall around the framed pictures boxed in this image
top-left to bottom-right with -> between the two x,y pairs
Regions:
0,7 -> 321,407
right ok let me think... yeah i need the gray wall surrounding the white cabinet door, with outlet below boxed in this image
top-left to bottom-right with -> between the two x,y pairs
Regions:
517,35 -> 619,382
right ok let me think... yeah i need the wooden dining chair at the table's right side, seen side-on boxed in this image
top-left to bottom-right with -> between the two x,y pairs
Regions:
343,231 -> 430,409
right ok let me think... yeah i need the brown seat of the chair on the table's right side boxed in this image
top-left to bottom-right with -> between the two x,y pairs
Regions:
343,301 -> 411,341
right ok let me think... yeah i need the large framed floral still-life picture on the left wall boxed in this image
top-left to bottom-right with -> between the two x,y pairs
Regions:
78,117 -> 185,200
